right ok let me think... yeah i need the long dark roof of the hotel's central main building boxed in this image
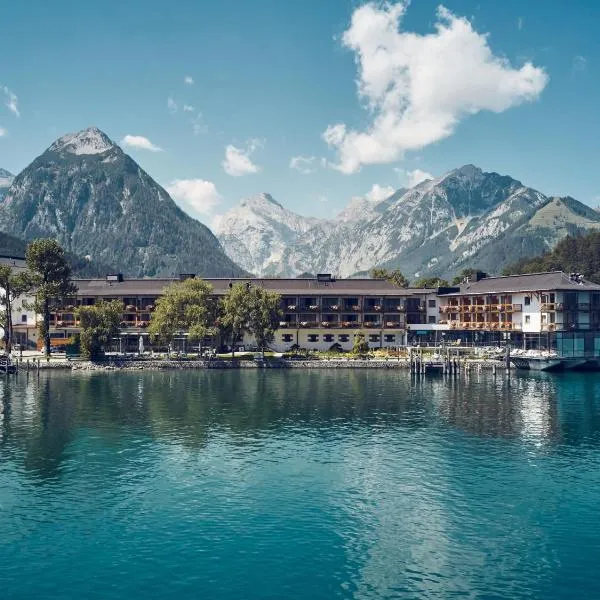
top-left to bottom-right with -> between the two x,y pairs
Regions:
74,278 -> 435,297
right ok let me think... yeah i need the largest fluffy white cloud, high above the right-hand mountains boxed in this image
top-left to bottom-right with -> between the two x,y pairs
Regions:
323,2 -> 548,173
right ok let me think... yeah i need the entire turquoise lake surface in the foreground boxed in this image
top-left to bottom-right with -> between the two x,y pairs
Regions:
0,371 -> 600,599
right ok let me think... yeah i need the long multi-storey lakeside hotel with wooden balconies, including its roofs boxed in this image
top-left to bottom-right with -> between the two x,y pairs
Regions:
7,272 -> 600,353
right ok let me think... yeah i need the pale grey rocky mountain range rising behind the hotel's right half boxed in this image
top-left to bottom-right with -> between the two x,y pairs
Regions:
217,165 -> 600,279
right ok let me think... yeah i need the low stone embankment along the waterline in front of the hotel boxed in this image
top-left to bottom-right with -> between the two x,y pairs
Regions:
17,358 -> 501,371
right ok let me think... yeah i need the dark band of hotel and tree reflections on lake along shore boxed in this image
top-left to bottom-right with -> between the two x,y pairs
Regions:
0,370 -> 600,478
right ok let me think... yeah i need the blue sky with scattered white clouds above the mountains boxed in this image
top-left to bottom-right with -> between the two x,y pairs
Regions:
0,0 -> 600,225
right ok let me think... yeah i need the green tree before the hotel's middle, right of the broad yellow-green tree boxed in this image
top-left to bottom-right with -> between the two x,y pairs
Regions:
221,282 -> 281,357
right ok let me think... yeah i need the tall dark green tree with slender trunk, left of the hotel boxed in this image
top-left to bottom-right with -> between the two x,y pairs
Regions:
25,239 -> 77,357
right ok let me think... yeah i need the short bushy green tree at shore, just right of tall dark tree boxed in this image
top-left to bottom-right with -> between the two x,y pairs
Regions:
75,300 -> 123,360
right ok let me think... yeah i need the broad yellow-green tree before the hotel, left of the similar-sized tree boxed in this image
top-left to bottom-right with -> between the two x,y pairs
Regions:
148,278 -> 216,351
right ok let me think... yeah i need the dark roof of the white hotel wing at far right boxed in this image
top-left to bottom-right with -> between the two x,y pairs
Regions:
443,271 -> 600,296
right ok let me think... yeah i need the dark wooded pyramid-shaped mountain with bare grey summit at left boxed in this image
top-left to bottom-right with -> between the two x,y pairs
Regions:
0,127 -> 243,276
